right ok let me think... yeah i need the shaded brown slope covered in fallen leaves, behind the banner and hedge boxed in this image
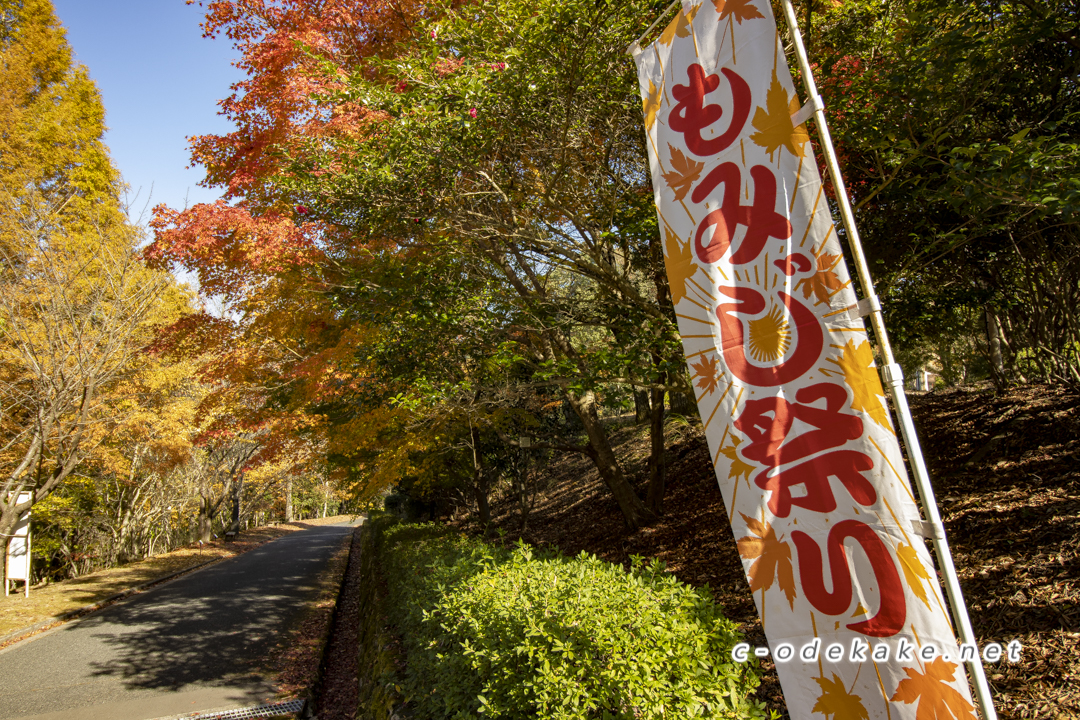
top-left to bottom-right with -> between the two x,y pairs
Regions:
470,386 -> 1080,718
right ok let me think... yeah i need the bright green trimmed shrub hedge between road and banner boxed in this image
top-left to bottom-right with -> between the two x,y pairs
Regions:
379,525 -> 766,720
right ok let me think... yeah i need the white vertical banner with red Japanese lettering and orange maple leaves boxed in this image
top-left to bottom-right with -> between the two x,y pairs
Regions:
635,0 -> 975,720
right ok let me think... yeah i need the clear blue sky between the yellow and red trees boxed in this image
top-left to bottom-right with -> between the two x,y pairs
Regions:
53,0 -> 242,221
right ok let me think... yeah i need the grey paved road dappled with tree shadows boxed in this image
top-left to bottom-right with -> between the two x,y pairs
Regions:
0,526 -> 352,720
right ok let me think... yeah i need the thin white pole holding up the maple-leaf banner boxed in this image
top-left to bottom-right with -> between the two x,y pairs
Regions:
783,0 -> 998,720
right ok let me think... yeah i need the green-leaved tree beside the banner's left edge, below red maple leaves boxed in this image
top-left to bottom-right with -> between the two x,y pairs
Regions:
278,2 -> 686,527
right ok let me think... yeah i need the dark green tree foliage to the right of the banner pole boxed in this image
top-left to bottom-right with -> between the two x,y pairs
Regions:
812,0 -> 1080,383
